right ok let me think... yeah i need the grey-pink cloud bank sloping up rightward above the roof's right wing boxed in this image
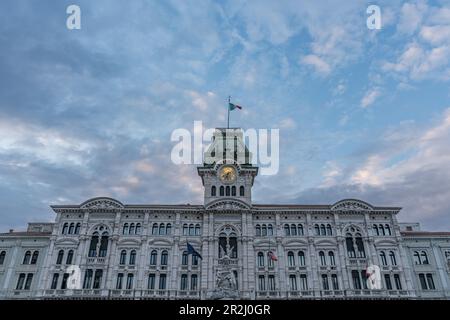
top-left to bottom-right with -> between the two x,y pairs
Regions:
281,108 -> 450,230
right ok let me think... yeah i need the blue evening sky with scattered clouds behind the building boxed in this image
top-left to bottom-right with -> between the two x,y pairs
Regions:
0,0 -> 450,232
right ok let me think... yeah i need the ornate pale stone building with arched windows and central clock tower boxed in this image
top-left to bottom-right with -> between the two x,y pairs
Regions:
0,129 -> 450,299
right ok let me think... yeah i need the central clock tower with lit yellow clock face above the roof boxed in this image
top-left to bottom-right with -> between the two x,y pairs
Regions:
197,128 -> 258,206
